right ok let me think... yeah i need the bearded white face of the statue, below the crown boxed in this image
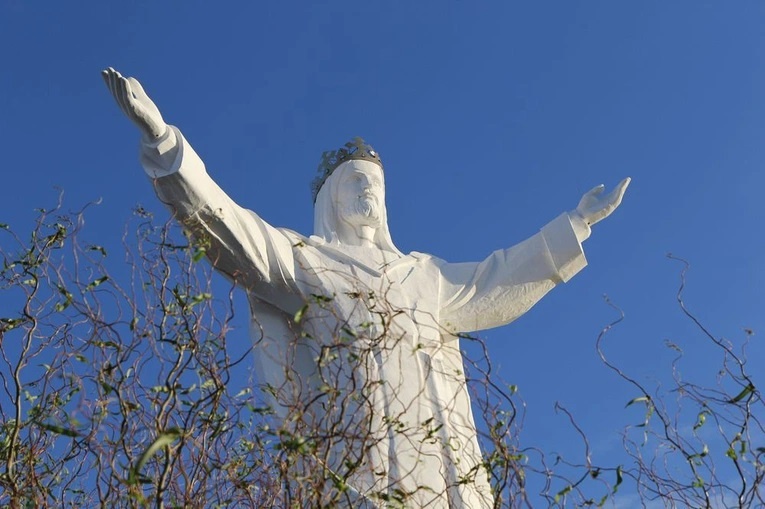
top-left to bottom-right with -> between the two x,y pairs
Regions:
335,161 -> 385,228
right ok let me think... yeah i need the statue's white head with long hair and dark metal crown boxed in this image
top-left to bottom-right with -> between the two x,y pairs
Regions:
313,138 -> 401,255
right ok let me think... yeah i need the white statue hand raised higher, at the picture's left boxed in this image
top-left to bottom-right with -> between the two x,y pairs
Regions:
101,67 -> 167,138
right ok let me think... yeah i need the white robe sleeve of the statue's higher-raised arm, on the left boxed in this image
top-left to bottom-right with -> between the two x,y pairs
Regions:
141,127 -> 302,313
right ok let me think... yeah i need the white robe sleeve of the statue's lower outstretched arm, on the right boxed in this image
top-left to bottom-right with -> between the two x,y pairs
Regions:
432,214 -> 589,333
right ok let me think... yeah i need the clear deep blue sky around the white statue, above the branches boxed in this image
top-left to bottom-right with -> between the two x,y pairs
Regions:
0,0 -> 765,504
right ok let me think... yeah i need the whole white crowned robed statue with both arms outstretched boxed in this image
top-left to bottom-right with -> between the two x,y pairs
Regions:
103,68 -> 630,509
